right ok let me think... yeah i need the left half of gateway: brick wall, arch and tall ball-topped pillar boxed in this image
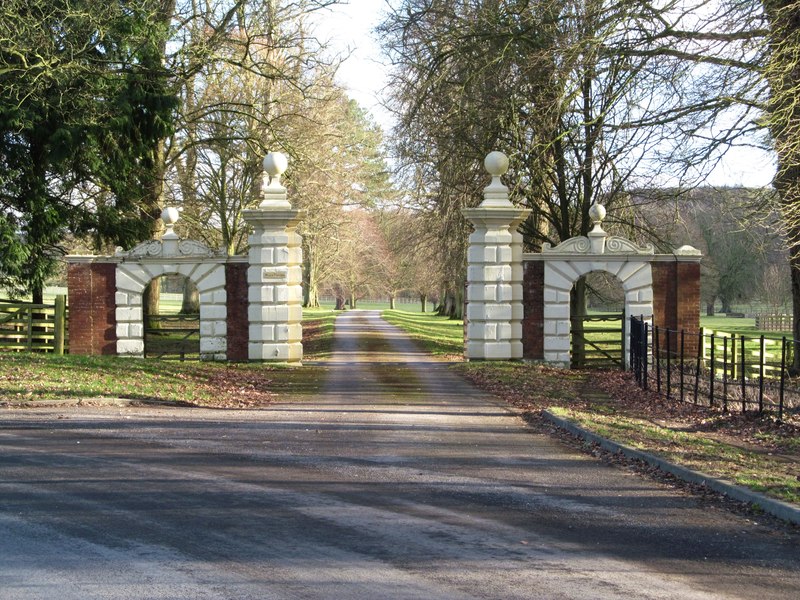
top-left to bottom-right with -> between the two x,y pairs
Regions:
67,153 -> 304,362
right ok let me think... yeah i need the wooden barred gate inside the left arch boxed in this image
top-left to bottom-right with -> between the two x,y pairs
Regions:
144,315 -> 200,360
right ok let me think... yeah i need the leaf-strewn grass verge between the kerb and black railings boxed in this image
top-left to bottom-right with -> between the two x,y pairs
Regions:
454,363 -> 800,505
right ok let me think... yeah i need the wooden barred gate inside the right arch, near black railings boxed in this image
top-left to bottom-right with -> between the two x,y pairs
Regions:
571,313 -> 625,369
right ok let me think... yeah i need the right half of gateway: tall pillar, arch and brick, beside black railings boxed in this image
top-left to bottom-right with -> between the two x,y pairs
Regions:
463,152 -> 701,366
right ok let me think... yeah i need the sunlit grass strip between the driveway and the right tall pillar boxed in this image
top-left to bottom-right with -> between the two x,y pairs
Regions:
381,310 -> 464,360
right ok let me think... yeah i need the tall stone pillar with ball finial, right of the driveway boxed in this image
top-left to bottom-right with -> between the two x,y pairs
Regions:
462,152 -> 530,360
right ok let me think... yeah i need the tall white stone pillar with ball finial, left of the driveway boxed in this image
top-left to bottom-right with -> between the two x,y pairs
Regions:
244,152 -> 305,363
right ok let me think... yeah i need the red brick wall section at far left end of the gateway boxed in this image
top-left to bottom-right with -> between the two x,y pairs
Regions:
67,263 -> 117,355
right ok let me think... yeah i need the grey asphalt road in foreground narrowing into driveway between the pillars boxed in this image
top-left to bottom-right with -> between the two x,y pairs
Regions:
0,311 -> 800,600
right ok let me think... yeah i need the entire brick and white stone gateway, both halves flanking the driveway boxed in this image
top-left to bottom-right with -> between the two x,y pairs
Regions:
67,152 -> 700,366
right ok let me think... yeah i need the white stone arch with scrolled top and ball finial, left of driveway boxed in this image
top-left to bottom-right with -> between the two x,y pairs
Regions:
114,209 -> 229,360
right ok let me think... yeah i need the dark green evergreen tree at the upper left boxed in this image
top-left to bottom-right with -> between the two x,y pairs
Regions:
0,0 -> 177,301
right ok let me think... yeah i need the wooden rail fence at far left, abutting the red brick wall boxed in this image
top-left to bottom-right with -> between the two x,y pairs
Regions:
0,296 -> 67,355
